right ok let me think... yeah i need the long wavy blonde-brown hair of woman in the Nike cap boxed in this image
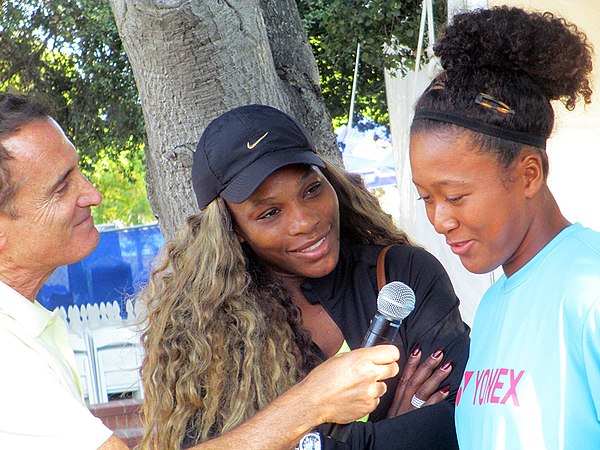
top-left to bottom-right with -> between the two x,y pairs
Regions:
138,156 -> 410,449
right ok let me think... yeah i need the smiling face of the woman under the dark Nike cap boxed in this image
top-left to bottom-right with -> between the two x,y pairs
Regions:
227,165 -> 340,278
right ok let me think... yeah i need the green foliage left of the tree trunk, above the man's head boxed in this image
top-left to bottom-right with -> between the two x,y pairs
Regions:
0,0 -> 155,225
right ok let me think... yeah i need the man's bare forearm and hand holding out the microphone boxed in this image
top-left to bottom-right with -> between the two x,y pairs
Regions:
194,345 -> 399,450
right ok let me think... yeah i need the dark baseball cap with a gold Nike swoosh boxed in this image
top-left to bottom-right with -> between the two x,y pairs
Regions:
192,105 -> 325,209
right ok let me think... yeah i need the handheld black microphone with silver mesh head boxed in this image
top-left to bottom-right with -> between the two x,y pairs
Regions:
326,281 -> 415,442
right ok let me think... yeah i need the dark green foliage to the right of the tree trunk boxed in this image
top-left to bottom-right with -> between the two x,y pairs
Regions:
297,0 -> 447,126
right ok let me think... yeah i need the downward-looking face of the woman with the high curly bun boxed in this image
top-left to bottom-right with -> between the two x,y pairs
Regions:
410,131 -> 533,274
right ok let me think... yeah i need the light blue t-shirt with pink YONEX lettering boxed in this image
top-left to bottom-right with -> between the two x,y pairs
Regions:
456,224 -> 600,450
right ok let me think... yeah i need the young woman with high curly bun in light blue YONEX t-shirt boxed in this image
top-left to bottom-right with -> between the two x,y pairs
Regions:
410,7 -> 600,449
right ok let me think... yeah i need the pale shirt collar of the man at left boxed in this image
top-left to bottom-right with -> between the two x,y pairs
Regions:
0,281 -> 57,337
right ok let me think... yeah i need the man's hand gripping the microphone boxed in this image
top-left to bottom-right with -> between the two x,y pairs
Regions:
298,345 -> 400,424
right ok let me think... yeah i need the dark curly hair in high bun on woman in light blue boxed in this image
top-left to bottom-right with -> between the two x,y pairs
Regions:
411,6 -> 592,175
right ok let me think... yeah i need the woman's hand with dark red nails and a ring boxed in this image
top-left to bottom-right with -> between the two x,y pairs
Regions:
387,345 -> 452,418
